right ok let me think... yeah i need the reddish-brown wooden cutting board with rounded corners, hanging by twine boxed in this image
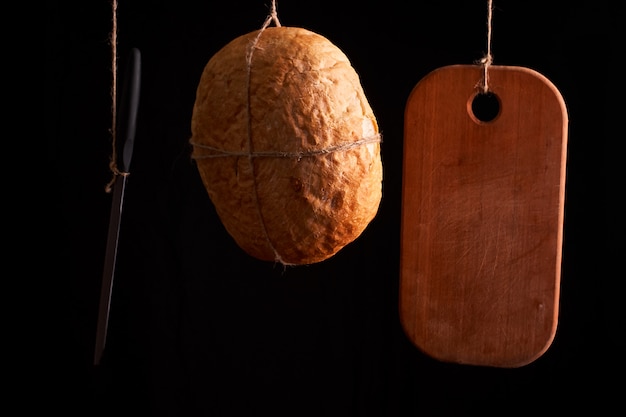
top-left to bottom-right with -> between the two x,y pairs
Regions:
399,65 -> 568,367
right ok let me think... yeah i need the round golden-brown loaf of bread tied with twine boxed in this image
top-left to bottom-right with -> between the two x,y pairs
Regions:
191,26 -> 382,265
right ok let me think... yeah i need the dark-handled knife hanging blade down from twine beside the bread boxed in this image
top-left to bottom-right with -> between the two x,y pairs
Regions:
94,48 -> 141,365
